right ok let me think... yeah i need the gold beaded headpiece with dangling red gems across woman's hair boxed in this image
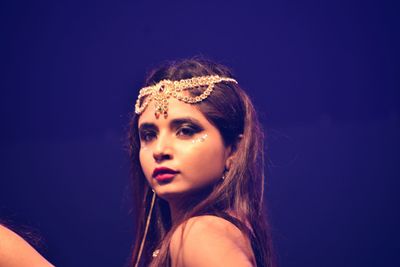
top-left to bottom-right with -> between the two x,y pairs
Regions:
135,75 -> 237,118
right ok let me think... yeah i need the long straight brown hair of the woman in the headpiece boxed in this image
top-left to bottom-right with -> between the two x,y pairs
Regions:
128,58 -> 275,267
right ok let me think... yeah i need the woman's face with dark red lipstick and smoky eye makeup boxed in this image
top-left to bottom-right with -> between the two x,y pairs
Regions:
138,98 -> 231,200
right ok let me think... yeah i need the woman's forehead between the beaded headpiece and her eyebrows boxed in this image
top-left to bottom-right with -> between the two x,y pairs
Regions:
138,98 -> 208,125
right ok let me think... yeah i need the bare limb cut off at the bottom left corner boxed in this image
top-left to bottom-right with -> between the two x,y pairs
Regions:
0,224 -> 53,267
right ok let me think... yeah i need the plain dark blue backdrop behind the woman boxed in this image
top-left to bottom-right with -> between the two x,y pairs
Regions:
0,0 -> 400,267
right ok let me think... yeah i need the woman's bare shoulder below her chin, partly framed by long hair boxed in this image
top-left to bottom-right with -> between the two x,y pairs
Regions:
170,215 -> 255,267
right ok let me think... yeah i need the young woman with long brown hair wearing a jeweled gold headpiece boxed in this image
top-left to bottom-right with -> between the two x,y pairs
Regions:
129,59 -> 275,267
